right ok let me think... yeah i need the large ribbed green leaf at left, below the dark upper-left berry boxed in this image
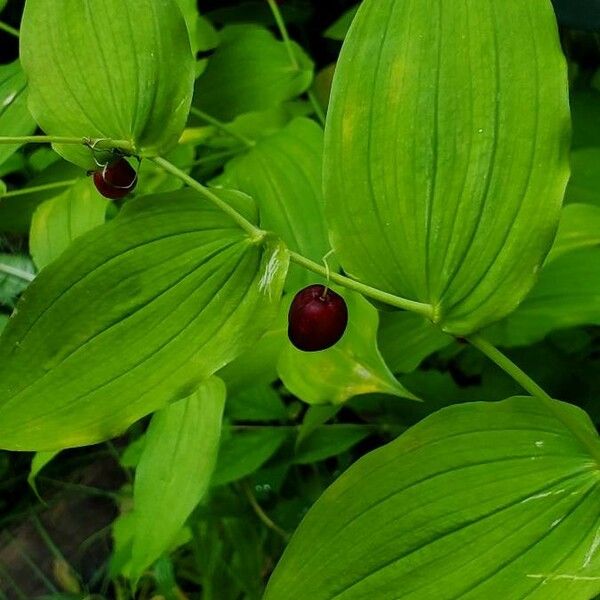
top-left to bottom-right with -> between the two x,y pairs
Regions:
0,190 -> 287,450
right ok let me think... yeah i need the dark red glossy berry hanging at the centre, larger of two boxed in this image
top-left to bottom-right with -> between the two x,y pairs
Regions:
288,284 -> 348,352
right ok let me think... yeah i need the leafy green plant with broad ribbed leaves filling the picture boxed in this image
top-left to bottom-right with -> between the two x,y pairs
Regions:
0,0 -> 600,600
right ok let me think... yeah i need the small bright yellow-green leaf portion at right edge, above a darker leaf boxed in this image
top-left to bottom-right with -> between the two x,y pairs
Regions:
546,204 -> 600,263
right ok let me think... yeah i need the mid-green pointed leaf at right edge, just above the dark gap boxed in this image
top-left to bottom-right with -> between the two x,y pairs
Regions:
488,247 -> 600,346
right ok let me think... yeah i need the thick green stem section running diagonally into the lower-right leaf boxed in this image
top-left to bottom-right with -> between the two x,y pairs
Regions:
467,335 -> 600,463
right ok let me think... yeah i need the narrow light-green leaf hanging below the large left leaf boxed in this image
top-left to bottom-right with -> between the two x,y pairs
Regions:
131,377 -> 225,580
